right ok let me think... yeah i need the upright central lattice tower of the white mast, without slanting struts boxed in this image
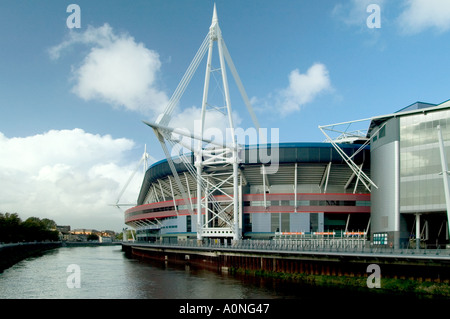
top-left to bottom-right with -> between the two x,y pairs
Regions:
195,5 -> 240,239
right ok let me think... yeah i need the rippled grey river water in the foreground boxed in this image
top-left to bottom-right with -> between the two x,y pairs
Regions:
0,245 -> 444,302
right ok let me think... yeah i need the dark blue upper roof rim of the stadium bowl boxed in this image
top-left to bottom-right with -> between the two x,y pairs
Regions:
138,143 -> 370,204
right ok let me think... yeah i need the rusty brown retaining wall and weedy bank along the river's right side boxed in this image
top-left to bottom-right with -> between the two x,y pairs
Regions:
122,244 -> 450,300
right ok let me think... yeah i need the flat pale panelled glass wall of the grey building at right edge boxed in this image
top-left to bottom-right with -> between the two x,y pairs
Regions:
400,110 -> 450,213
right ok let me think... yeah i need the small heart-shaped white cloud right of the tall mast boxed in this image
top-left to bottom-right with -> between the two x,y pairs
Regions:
276,63 -> 331,116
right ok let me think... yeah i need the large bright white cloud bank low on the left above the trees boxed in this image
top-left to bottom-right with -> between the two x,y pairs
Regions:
0,129 -> 143,231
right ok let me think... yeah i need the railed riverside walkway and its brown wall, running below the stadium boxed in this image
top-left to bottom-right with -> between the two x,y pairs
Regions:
122,239 -> 450,283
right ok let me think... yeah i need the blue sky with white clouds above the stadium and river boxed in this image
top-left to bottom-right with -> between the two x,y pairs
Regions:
0,0 -> 450,231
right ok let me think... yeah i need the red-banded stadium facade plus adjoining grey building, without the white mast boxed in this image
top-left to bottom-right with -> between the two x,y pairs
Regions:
125,101 -> 450,247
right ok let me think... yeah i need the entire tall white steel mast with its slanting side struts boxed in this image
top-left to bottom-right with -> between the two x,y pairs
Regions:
145,5 -> 260,240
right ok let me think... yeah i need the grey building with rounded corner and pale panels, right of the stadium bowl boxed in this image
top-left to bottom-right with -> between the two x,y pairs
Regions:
368,101 -> 450,247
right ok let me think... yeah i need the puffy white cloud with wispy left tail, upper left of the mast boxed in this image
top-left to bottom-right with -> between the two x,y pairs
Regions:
49,24 -> 168,115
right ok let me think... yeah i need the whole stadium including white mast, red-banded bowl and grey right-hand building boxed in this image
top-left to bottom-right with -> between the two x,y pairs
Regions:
125,7 -> 450,248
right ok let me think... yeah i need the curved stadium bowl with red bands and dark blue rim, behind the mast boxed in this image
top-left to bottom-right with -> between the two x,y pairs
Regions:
125,143 -> 370,241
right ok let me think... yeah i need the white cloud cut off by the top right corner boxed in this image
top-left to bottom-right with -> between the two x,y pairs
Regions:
398,0 -> 450,34
